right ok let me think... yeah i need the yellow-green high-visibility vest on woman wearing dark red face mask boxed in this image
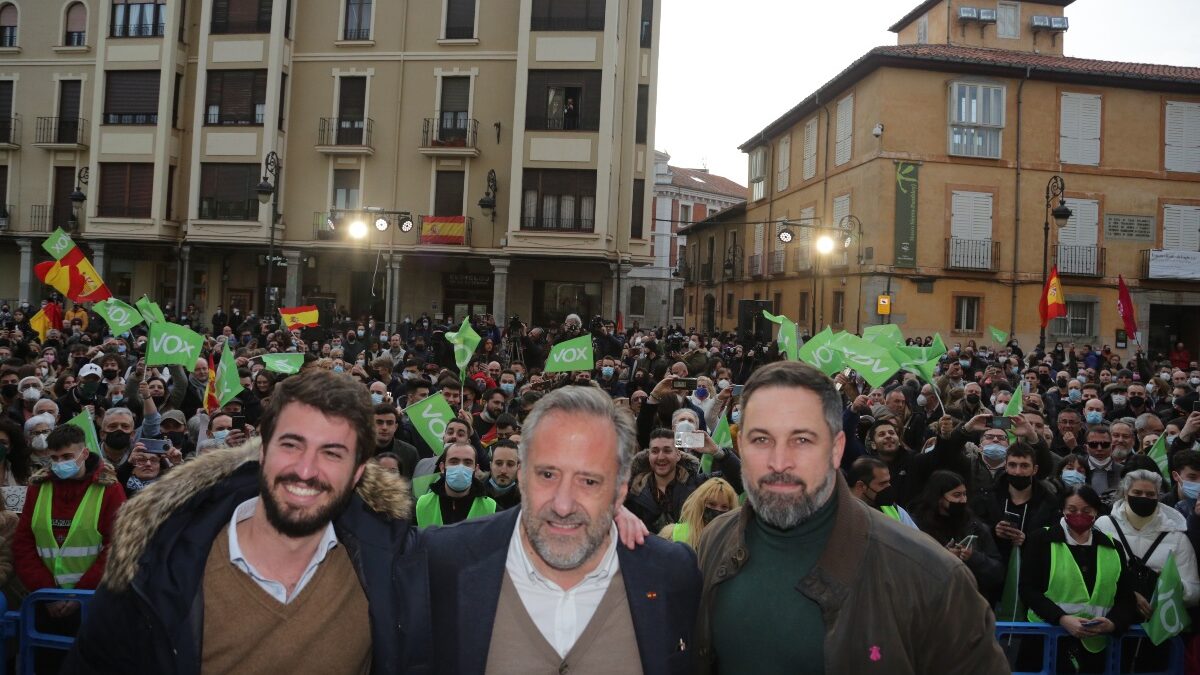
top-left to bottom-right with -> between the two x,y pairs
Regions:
1027,533 -> 1121,653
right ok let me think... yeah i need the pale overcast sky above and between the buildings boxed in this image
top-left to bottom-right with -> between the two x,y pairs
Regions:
655,0 -> 1200,185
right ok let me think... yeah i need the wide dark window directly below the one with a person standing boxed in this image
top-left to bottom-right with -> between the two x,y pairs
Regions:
521,169 -> 596,232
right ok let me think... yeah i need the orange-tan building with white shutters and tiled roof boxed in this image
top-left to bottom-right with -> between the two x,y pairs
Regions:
684,0 -> 1200,351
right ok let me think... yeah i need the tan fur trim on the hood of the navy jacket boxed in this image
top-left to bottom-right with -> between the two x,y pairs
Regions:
102,438 -> 422,591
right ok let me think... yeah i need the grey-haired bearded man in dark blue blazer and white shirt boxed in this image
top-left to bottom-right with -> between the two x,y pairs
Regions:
425,387 -> 700,675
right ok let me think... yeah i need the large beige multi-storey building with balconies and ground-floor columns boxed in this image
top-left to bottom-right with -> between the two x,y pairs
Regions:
0,0 -> 659,329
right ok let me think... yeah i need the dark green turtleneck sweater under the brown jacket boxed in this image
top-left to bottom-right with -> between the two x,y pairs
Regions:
713,495 -> 838,675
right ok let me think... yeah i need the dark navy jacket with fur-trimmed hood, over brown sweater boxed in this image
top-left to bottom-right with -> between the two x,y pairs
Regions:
64,440 -> 431,674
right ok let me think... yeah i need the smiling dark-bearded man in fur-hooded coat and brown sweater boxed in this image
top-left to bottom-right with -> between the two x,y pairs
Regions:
65,369 -> 431,673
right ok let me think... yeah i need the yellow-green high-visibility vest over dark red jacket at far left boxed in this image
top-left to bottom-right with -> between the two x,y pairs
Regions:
30,482 -> 104,589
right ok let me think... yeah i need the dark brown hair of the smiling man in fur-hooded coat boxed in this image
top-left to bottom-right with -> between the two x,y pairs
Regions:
260,369 -> 374,466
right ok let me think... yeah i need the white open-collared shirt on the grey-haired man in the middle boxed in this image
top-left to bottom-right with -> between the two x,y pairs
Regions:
505,518 -> 620,658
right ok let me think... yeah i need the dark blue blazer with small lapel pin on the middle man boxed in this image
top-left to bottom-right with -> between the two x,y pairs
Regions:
421,508 -> 701,675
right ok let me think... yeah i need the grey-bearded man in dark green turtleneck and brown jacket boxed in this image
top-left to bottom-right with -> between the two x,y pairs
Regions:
696,362 -> 1009,674
